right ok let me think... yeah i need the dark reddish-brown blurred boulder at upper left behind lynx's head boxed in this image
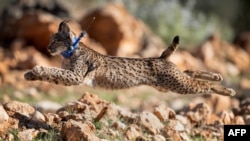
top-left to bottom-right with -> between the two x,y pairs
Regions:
0,11 -> 81,53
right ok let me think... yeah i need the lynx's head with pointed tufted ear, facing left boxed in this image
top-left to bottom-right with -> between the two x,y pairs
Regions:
48,21 -> 76,55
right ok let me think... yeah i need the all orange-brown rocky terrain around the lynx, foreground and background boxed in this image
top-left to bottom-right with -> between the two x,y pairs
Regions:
0,1 -> 250,141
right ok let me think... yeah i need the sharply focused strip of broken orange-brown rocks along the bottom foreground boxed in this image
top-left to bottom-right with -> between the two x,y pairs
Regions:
0,92 -> 250,141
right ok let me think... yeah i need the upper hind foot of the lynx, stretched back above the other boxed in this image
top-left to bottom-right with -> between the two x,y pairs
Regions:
184,70 -> 223,81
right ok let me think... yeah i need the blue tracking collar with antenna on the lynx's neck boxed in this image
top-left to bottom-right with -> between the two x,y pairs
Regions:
61,31 -> 87,58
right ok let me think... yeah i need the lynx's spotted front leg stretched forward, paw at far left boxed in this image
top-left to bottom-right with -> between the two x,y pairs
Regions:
24,66 -> 83,86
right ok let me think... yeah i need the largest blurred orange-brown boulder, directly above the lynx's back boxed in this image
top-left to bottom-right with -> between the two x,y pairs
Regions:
80,3 -> 165,57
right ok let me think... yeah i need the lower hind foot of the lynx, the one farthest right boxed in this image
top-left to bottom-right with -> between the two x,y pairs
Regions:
211,85 -> 236,96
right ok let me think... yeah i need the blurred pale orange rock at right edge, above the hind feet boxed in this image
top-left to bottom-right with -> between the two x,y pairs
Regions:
196,34 -> 250,76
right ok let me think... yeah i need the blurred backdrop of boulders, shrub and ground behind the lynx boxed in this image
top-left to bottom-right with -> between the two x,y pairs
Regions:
0,0 -> 250,112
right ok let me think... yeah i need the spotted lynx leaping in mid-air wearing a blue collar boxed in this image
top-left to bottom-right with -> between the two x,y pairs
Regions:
24,21 -> 235,96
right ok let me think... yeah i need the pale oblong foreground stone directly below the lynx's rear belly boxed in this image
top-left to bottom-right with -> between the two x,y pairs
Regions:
139,112 -> 164,135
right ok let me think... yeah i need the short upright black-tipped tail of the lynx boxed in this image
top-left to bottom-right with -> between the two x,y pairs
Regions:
160,36 -> 180,59
